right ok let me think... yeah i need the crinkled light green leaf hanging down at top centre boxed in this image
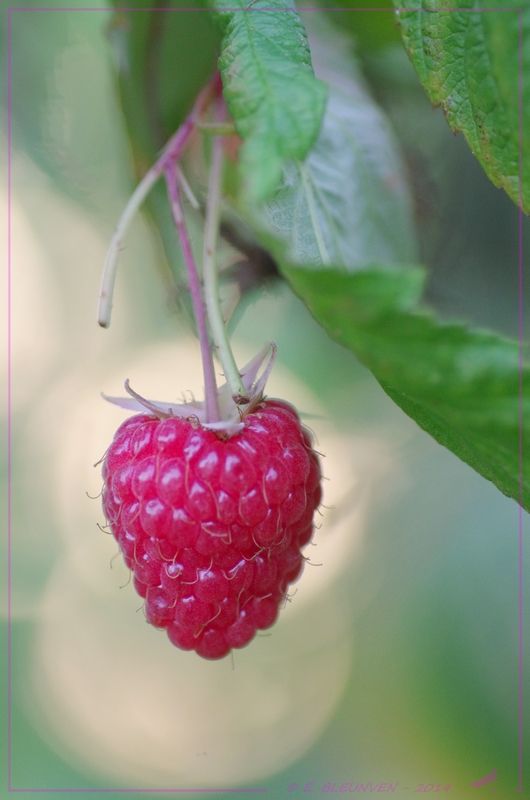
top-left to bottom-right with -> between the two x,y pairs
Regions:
207,0 -> 326,201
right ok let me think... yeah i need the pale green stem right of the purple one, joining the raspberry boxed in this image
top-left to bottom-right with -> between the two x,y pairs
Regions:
203,104 -> 246,397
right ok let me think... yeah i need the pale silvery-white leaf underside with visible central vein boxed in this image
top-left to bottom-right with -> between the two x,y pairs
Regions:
251,15 -> 416,270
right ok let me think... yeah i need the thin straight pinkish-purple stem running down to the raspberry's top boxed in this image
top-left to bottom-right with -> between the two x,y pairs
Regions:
165,161 -> 220,422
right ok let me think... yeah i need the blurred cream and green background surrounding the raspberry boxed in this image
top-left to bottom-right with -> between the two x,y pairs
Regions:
1,0 -> 530,800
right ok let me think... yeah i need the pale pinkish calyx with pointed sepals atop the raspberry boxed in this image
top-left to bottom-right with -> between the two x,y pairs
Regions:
102,342 -> 276,438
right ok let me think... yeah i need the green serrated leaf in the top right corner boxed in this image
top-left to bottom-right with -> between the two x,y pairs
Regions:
394,0 -> 530,213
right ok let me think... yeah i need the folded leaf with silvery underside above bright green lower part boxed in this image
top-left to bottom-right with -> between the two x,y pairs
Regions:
233,14 -> 530,507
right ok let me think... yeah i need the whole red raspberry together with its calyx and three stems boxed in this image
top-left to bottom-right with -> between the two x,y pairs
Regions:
99,76 -> 321,659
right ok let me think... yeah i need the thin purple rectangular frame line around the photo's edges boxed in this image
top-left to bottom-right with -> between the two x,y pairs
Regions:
4,3 -> 524,794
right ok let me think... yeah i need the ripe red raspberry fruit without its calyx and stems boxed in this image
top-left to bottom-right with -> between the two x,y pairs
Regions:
103,400 -> 321,659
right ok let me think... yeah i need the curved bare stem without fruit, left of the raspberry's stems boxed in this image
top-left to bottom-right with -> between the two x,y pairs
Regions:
98,73 -> 221,328
